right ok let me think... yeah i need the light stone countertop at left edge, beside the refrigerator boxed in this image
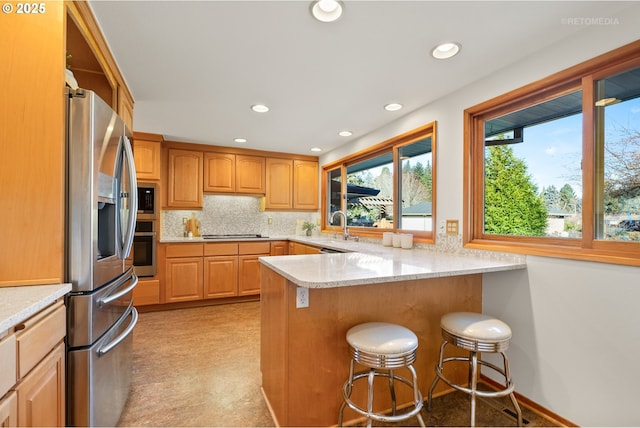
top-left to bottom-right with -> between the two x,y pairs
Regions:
0,284 -> 71,337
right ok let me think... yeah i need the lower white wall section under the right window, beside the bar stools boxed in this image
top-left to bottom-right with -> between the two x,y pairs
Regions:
483,256 -> 640,426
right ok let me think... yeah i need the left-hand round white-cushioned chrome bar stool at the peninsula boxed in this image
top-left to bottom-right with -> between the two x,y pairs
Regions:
338,322 -> 425,427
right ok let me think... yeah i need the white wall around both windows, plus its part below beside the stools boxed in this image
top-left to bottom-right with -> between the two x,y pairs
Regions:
320,2 -> 640,426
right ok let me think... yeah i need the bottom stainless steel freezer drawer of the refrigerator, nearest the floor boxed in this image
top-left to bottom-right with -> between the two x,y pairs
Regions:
67,306 -> 138,427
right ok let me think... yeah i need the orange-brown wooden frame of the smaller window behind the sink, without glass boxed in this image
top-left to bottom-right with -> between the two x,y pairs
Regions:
320,121 -> 437,244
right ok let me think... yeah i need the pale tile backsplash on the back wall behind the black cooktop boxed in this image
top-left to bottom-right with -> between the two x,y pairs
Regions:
160,195 -> 320,238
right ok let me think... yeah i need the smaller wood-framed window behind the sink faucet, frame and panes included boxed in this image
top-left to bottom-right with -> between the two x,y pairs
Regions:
322,122 -> 435,242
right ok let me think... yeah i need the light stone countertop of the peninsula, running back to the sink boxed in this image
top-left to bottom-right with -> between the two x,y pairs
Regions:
260,236 -> 527,288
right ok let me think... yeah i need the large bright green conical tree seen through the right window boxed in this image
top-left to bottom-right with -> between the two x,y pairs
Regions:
484,145 -> 547,236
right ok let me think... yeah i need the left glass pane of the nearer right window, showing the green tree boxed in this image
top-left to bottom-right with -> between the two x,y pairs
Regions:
483,90 -> 582,238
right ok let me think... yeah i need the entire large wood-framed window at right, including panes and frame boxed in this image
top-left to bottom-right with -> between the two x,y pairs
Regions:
464,42 -> 640,265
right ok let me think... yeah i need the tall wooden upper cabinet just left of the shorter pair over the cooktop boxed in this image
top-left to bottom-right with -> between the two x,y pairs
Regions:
167,149 -> 203,208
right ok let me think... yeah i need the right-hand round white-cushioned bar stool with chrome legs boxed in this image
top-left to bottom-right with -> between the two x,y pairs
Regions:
427,312 -> 522,427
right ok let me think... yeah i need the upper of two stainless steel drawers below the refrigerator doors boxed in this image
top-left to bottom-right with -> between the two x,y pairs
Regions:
67,268 -> 138,348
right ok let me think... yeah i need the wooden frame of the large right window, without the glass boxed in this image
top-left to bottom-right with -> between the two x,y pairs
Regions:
463,41 -> 640,266
